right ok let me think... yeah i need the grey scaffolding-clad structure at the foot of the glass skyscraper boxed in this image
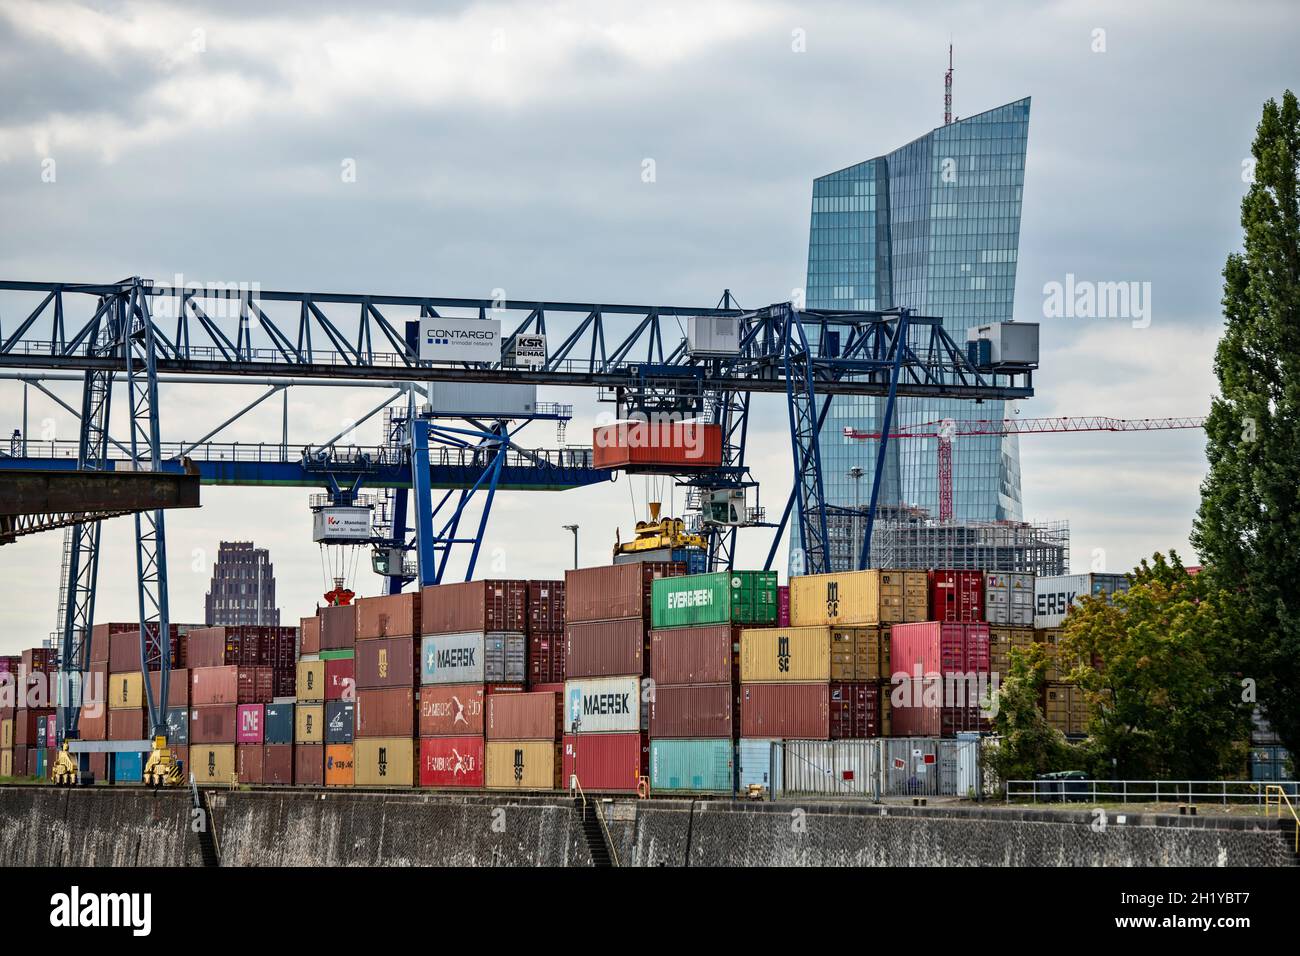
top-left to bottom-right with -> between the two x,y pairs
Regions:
827,506 -> 1070,576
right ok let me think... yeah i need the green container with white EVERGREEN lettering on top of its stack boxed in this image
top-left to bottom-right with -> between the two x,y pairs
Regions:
650,571 -> 776,627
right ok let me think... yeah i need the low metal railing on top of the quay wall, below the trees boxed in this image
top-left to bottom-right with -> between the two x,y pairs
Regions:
1006,778 -> 1300,806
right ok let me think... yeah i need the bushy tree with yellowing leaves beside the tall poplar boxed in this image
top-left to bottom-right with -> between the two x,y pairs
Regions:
1060,551 -> 1253,780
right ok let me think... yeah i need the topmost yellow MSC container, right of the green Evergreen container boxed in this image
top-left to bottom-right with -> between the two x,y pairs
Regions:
790,570 -> 928,627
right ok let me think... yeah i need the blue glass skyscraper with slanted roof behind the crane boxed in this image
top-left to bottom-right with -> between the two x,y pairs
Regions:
793,98 -> 1030,567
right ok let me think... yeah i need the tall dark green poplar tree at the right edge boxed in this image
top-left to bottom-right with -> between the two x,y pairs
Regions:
1192,90 -> 1300,753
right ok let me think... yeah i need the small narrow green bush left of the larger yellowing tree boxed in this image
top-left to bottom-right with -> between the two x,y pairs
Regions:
984,644 -> 1083,780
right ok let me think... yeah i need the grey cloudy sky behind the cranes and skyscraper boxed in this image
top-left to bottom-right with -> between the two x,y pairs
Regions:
0,0 -> 1300,650
